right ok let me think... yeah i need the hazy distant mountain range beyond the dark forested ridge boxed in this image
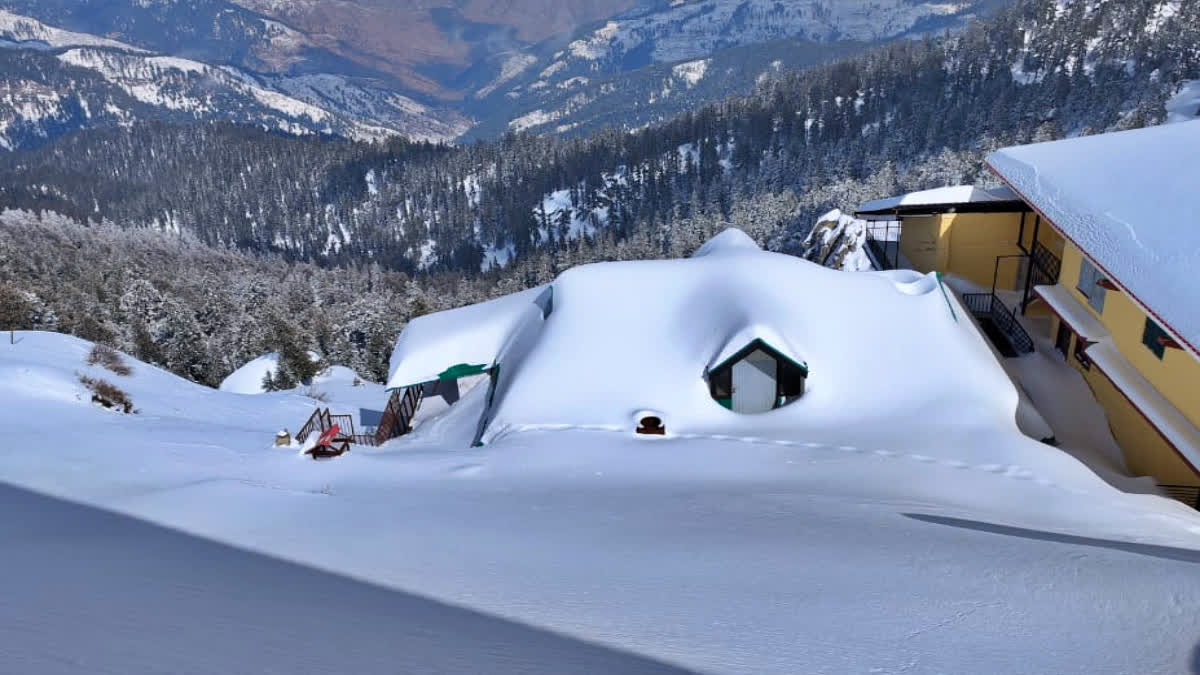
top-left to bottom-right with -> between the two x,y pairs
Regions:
0,0 -> 1017,148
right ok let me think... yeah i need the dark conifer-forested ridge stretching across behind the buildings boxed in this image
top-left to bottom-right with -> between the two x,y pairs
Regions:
0,0 -> 1200,279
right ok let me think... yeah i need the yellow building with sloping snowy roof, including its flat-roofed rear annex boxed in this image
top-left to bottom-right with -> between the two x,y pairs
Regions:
858,123 -> 1200,492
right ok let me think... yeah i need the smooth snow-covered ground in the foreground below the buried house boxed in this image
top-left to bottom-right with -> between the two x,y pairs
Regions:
0,281 -> 1200,674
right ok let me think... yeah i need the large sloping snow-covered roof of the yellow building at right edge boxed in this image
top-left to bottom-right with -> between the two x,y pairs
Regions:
988,121 -> 1200,354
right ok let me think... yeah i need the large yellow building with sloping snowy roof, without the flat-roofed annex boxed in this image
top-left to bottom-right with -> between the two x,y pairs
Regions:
988,123 -> 1200,486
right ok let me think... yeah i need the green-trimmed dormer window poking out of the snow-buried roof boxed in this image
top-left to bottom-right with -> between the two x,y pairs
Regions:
706,339 -> 809,414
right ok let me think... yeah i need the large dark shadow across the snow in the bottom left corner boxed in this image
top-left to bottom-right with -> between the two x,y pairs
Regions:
0,484 -> 700,675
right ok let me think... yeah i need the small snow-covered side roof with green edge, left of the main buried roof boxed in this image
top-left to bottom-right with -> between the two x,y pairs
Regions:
388,286 -> 548,389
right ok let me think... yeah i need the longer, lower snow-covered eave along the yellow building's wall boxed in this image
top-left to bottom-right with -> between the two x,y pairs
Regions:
1084,339 -> 1200,476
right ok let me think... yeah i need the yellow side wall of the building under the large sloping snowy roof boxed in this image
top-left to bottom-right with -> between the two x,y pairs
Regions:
1051,243 -> 1200,485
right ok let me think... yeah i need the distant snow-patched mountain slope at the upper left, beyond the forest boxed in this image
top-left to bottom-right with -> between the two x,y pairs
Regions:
0,0 -> 470,148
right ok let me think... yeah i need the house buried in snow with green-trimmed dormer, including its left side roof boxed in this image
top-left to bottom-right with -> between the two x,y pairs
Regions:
388,229 -> 1040,444
